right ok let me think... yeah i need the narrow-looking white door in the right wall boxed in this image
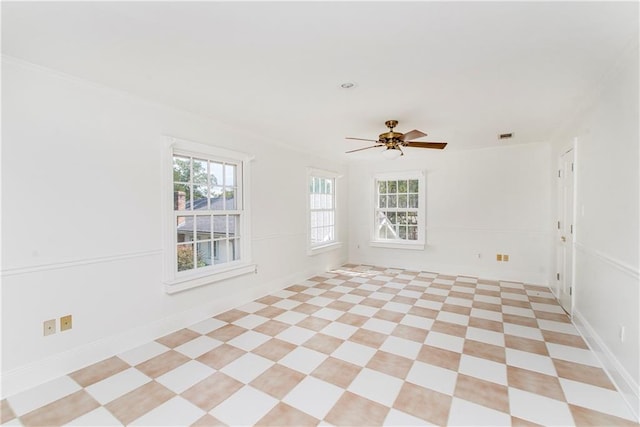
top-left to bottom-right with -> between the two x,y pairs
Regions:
556,149 -> 575,315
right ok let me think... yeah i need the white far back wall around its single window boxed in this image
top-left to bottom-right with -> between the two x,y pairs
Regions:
349,143 -> 551,284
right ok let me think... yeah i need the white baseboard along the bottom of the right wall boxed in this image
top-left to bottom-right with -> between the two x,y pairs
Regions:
573,308 -> 640,421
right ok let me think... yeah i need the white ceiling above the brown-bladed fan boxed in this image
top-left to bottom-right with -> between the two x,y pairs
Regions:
2,1 -> 639,158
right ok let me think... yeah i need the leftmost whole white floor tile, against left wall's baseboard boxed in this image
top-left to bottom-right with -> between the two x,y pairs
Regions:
7,376 -> 82,417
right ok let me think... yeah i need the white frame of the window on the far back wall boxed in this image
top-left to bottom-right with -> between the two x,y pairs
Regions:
369,170 -> 426,250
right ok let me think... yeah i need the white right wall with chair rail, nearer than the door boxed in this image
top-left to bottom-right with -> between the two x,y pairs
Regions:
553,40 -> 640,414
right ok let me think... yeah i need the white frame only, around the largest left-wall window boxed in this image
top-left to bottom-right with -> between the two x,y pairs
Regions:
162,137 -> 256,294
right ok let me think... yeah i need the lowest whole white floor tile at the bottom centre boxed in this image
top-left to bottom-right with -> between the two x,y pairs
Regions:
284,377 -> 344,424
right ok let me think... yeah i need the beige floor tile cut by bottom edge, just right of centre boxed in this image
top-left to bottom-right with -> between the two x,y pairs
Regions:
325,391 -> 389,426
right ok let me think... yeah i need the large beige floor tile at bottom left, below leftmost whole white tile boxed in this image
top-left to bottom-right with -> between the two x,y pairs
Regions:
20,390 -> 100,426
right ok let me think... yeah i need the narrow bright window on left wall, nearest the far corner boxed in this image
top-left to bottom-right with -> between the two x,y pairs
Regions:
307,169 -> 340,254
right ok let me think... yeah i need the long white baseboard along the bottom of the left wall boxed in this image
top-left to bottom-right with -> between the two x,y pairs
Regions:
0,270 -> 321,399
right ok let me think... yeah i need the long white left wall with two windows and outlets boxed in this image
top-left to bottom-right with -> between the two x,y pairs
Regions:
2,58 -> 347,396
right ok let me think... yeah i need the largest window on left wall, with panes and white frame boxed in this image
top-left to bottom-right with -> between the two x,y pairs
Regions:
165,139 -> 255,293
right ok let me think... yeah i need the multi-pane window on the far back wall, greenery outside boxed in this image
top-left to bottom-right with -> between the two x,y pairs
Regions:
372,172 -> 425,249
